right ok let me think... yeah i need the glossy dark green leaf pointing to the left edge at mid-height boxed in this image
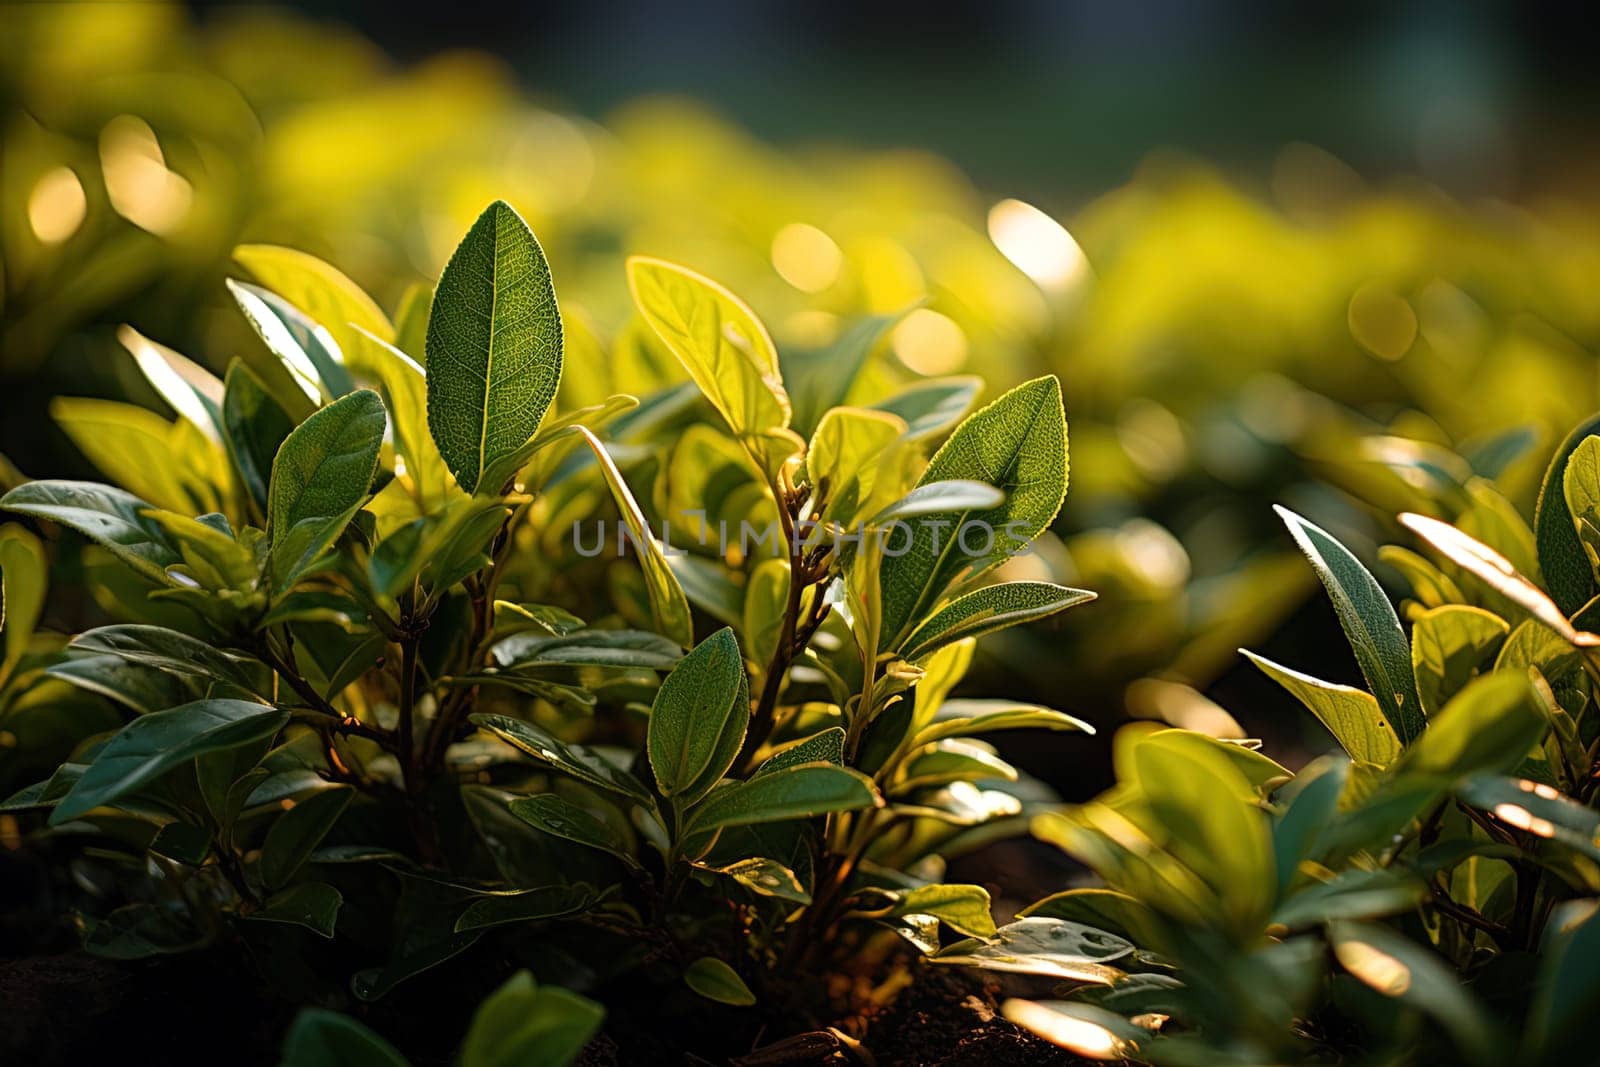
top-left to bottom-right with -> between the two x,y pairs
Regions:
0,482 -> 182,584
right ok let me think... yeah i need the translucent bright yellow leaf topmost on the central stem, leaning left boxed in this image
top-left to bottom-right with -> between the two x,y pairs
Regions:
627,256 -> 802,474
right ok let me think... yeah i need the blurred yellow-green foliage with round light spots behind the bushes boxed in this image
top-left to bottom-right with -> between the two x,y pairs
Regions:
9,2 -> 1600,795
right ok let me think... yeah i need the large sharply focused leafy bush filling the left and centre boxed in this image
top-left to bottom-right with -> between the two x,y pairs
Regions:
0,202 -> 1091,1064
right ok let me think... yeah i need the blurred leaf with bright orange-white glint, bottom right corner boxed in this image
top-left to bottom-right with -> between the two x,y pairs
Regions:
1328,921 -> 1499,1064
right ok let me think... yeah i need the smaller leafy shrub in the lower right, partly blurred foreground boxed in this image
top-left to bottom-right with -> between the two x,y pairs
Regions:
936,421 -> 1600,1064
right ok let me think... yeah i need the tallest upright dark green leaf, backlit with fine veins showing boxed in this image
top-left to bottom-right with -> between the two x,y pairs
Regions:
427,200 -> 562,493
